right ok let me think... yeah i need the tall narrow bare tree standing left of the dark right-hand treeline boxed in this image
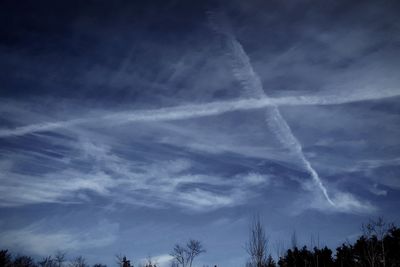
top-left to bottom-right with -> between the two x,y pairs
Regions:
246,216 -> 268,267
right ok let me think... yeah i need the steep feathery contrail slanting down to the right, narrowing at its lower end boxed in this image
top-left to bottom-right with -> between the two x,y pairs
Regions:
209,13 -> 335,206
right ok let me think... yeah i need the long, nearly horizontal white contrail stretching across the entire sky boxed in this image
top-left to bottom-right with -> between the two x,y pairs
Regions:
0,90 -> 400,139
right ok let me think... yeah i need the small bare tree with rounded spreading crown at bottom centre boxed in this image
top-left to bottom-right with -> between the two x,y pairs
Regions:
170,239 -> 206,267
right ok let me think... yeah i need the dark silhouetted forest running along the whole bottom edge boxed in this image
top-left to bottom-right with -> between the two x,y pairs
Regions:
0,218 -> 400,267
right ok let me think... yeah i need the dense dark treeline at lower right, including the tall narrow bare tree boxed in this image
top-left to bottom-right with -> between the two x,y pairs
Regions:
248,218 -> 400,267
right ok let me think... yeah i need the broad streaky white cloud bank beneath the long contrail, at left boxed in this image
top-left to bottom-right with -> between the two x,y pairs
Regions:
0,140 -> 274,211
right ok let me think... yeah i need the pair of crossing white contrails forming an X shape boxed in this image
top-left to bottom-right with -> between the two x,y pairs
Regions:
0,12 -> 400,206
